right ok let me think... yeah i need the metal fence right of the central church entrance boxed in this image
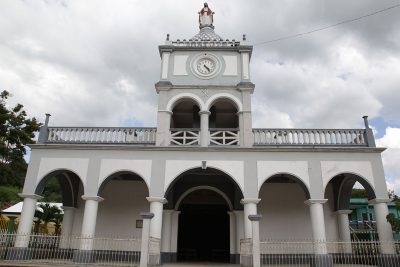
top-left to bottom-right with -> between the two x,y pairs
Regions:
260,241 -> 400,267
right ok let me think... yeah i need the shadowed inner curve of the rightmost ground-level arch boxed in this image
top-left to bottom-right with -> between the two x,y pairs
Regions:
324,172 -> 376,213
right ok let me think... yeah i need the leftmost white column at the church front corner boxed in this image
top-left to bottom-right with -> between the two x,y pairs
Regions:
15,194 -> 42,248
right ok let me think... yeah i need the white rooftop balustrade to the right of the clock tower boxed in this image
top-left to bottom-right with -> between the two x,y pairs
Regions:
253,129 -> 368,146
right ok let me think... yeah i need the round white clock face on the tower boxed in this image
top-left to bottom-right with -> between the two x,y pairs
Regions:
191,53 -> 221,79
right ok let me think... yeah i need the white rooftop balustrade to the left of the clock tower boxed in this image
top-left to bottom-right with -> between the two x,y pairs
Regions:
46,127 -> 157,144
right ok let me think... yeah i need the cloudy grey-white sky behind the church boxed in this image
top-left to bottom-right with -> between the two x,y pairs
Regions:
0,0 -> 400,194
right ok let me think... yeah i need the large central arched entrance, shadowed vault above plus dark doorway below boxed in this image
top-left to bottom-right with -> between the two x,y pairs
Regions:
166,168 -> 243,262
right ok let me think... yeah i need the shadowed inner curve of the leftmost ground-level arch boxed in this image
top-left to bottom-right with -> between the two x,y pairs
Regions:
35,169 -> 85,207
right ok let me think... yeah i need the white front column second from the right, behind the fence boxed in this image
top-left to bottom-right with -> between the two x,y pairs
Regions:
304,199 -> 328,254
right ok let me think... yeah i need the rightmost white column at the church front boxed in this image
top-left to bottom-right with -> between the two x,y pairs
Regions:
369,199 -> 396,254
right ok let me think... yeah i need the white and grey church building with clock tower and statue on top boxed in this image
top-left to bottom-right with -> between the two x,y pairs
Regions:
6,5 -> 395,266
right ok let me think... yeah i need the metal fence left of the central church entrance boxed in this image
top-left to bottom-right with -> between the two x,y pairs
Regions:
0,234 -> 141,266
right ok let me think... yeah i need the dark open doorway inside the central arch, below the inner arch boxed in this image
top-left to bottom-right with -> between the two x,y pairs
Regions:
178,204 -> 230,262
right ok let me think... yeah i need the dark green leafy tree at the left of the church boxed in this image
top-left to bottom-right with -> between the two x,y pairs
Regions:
0,91 -> 41,187
